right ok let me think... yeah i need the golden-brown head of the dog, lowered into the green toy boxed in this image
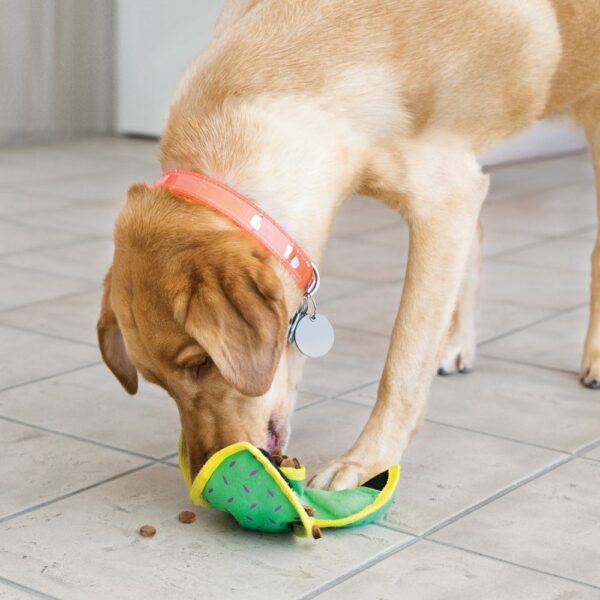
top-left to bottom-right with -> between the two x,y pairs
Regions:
98,184 -> 289,477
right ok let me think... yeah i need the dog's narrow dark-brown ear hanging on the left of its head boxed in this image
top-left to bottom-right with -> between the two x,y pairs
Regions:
96,269 -> 138,395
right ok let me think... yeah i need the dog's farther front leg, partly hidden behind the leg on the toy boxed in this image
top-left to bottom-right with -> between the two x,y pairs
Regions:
438,222 -> 483,375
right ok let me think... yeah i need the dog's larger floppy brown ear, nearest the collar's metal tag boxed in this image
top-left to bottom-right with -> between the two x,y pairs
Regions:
175,232 -> 287,396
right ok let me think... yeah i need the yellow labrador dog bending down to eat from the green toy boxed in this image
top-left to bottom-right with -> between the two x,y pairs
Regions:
98,0 -> 600,489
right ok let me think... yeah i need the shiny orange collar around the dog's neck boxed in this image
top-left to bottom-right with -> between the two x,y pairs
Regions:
155,170 -> 318,294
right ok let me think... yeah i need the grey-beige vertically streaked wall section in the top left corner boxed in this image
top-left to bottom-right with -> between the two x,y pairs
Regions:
0,0 -> 113,144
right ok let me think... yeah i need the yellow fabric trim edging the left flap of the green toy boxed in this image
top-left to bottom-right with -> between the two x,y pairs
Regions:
179,436 -> 313,537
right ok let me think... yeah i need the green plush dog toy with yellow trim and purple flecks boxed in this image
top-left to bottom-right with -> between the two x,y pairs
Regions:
179,436 -> 400,538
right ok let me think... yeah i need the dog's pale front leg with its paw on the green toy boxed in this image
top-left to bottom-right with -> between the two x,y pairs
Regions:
311,149 -> 489,489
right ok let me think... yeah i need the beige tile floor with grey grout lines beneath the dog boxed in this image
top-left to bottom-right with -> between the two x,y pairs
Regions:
0,138 -> 600,600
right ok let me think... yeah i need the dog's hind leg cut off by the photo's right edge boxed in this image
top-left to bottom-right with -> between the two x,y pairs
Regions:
581,118 -> 600,388
